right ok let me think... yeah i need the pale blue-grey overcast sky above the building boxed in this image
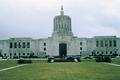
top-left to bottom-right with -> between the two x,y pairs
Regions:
0,0 -> 120,39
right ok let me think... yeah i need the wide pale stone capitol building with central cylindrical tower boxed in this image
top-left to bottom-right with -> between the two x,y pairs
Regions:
0,7 -> 120,59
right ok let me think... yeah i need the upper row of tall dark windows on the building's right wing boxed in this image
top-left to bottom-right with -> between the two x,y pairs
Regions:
96,40 -> 117,47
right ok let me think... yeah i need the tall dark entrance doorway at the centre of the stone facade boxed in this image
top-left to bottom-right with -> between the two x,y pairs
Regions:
59,43 -> 67,57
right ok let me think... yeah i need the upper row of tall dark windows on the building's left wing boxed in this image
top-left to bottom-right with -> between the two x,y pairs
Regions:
10,42 -> 30,48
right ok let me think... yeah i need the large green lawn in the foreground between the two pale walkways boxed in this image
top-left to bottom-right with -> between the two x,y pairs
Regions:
0,61 -> 120,80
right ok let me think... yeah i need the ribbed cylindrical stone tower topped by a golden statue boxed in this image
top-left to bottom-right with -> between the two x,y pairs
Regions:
53,6 -> 73,36
